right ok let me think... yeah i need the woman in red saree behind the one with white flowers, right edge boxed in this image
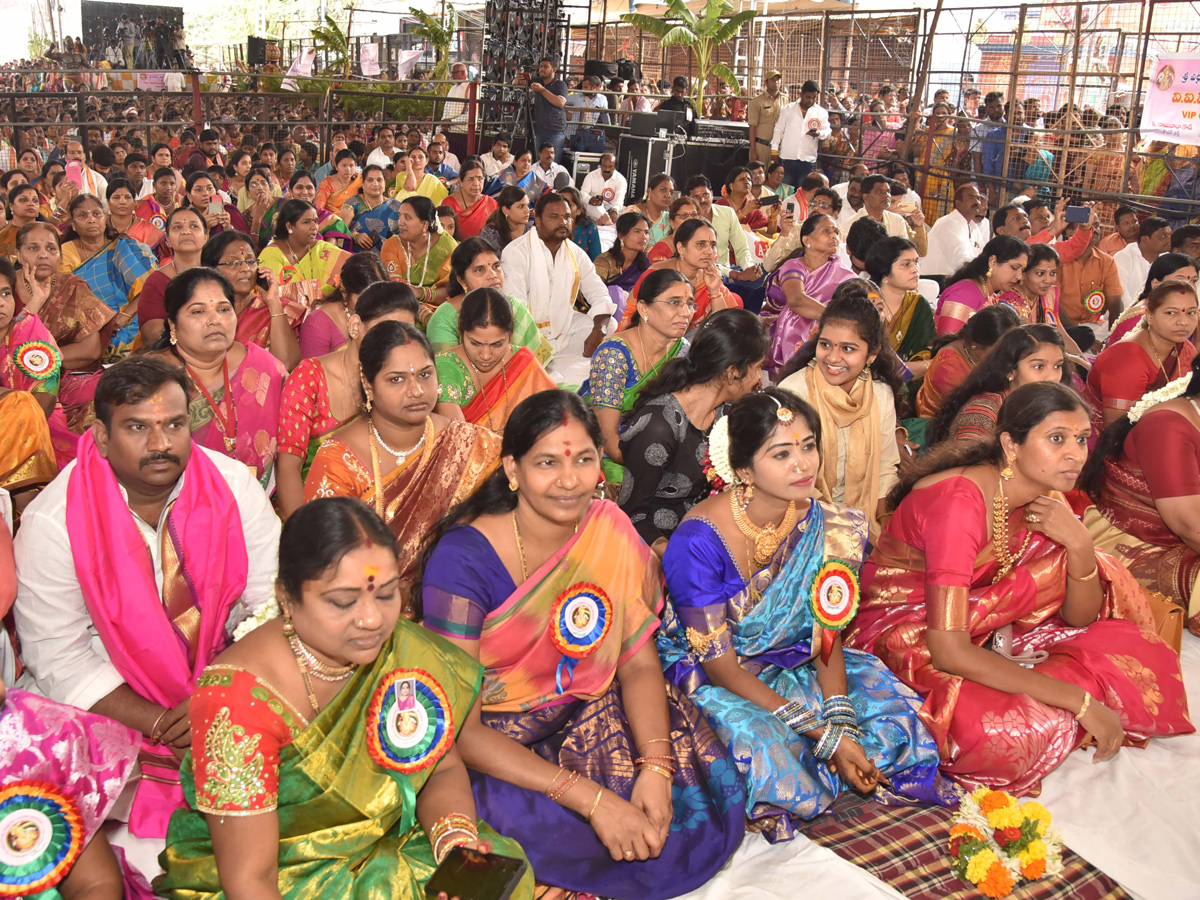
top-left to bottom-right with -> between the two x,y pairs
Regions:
1085,281 -> 1198,434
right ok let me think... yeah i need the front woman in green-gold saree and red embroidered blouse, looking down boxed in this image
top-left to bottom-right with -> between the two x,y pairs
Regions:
154,498 -> 533,900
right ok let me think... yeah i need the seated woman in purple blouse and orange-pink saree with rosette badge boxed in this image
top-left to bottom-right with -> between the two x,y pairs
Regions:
421,390 -> 745,900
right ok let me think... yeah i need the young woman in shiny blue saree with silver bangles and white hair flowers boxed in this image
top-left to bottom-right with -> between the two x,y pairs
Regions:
658,388 -> 940,840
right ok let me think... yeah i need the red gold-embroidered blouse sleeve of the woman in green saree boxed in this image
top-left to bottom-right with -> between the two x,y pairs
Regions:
191,666 -> 308,816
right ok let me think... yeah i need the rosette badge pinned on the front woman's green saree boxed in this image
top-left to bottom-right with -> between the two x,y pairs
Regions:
367,668 -> 454,775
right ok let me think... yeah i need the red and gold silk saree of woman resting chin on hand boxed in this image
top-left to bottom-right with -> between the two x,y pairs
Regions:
846,487 -> 1194,793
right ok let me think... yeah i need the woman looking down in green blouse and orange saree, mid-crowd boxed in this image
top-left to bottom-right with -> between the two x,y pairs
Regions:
434,288 -> 557,434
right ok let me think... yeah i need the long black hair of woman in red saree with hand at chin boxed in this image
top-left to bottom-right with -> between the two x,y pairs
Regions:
888,382 -> 1087,510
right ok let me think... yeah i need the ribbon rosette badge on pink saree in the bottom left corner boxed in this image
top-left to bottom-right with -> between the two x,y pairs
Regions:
0,781 -> 83,896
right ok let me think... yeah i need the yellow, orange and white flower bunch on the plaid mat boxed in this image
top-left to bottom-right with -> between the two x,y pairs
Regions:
949,787 -> 1062,898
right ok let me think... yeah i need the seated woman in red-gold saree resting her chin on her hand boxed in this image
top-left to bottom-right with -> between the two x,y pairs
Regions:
846,383 -> 1194,793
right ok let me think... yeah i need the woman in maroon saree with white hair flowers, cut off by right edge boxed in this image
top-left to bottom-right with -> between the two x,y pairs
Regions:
1072,358 -> 1200,635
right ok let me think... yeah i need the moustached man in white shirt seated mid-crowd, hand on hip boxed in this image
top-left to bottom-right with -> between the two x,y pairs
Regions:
500,193 -> 617,380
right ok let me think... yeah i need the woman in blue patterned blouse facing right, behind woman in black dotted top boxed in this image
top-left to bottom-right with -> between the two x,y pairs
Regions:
580,269 -> 696,488
